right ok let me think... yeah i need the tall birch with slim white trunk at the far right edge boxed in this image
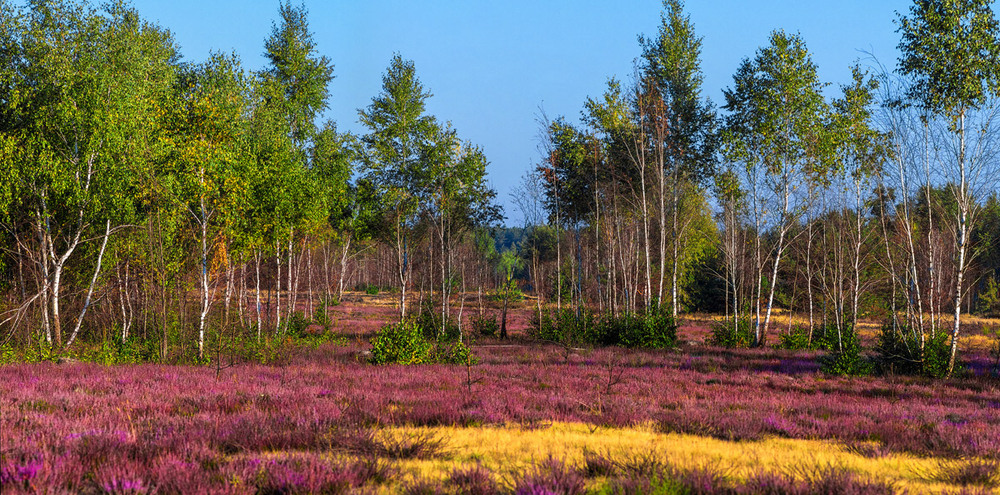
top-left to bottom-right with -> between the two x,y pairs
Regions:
899,0 -> 1000,375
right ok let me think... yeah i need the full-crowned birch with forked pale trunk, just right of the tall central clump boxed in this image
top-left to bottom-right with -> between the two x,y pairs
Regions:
724,31 -> 831,345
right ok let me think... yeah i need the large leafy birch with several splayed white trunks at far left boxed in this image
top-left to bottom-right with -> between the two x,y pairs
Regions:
0,1 -> 176,347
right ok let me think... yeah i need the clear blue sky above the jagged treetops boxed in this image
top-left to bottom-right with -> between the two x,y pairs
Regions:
119,0 -> 911,225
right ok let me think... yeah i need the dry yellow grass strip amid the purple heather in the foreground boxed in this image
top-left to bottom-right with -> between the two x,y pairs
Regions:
376,423 -> 1000,493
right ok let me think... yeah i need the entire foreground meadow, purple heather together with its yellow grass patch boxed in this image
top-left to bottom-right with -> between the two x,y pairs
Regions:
0,300 -> 1000,494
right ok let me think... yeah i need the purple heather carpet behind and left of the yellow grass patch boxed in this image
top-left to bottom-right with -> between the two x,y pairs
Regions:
0,326 -> 1000,493
